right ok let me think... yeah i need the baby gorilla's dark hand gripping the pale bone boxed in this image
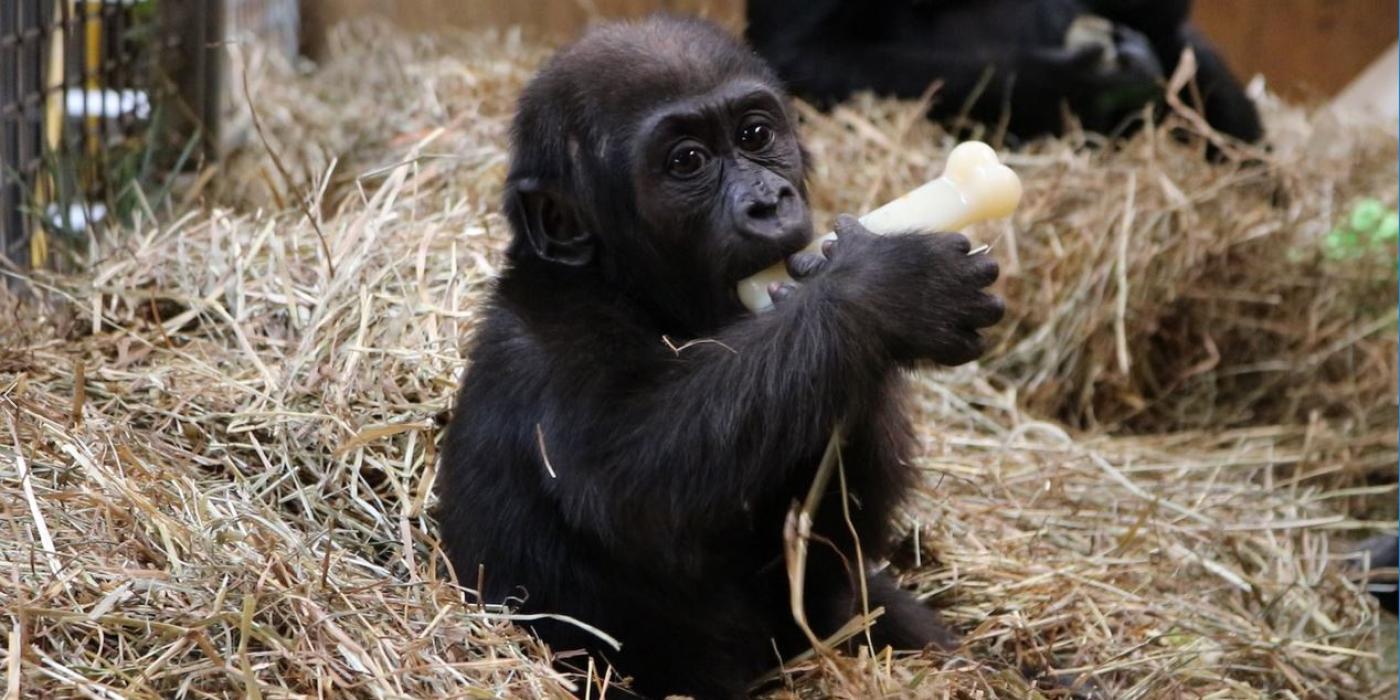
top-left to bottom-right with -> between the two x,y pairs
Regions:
788,216 -> 1004,365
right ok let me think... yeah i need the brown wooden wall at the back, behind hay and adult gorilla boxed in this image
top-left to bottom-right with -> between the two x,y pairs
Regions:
303,0 -> 1397,98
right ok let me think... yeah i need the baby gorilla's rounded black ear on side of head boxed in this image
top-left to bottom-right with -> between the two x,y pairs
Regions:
505,178 -> 595,267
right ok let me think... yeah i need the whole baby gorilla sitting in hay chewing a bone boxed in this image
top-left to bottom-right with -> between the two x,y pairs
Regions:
437,18 -> 1002,697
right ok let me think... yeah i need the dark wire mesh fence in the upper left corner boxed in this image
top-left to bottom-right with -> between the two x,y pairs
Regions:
0,0 -> 298,273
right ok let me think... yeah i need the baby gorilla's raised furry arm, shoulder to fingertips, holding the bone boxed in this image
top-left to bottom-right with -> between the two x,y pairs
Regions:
509,226 -> 1001,568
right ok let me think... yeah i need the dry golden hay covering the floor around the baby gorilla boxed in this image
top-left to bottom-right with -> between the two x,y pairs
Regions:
0,19 -> 1397,697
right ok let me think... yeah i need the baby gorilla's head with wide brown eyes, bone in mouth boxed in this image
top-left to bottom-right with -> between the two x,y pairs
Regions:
505,17 -> 812,333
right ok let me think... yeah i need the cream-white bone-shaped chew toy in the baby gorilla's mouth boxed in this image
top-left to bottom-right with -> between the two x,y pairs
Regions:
739,141 -> 1021,311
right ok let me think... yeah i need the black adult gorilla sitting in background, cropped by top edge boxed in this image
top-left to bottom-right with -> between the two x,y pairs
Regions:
748,0 -> 1263,147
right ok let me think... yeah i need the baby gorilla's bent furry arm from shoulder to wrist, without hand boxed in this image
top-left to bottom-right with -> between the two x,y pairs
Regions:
512,267 -> 892,570
